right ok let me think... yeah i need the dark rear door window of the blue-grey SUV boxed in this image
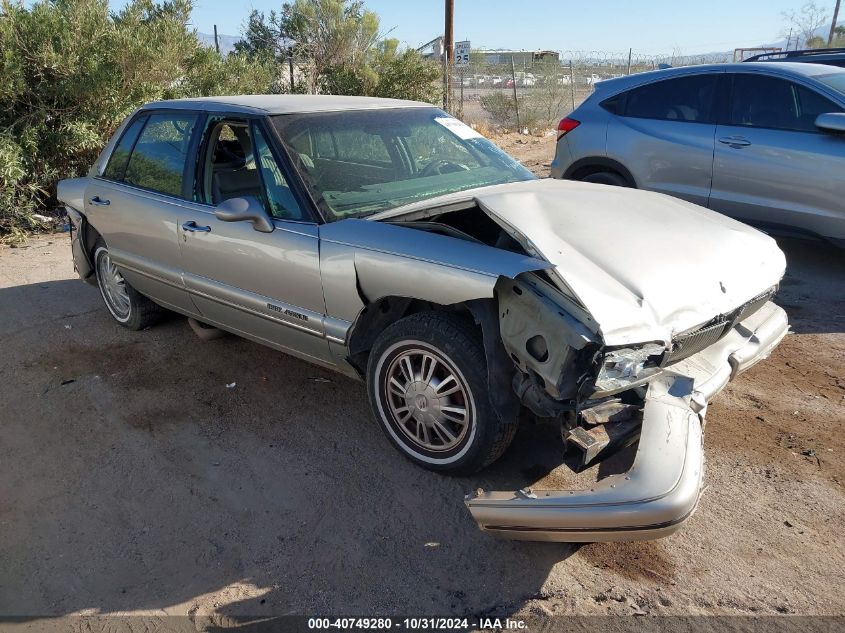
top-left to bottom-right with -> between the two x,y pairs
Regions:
625,74 -> 718,123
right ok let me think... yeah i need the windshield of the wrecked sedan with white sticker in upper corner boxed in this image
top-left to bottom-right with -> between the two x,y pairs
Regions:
273,108 -> 534,220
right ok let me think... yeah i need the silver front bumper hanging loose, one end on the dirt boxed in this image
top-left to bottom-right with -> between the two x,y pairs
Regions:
465,302 -> 789,542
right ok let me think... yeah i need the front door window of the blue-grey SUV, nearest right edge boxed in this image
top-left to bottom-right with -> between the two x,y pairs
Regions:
729,74 -> 842,132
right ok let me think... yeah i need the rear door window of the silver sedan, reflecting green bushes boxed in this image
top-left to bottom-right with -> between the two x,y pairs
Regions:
123,113 -> 197,197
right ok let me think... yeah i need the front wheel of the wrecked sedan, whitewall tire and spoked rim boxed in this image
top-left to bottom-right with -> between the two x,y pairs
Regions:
367,312 -> 517,474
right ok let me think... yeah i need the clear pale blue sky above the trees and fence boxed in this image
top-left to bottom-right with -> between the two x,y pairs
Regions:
104,0 -> 824,55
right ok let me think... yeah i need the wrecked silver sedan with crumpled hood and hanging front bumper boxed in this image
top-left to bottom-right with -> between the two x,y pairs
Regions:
58,95 -> 788,541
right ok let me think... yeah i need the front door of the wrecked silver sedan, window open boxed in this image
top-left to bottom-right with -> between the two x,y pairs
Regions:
179,117 -> 333,364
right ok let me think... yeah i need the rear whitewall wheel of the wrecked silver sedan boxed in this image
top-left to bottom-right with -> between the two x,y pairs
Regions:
94,239 -> 163,330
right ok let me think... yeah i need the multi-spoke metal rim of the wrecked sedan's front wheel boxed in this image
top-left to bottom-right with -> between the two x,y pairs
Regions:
385,348 -> 472,452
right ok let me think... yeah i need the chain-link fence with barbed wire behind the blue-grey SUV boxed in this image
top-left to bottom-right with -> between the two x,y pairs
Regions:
449,51 -> 731,131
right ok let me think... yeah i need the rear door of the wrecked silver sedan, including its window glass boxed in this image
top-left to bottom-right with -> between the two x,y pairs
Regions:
85,111 -> 200,311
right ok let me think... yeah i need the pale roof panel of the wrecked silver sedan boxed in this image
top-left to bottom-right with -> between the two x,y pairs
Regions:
141,95 -> 433,115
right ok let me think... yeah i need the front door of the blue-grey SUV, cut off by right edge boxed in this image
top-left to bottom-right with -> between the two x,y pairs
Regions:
710,73 -> 845,237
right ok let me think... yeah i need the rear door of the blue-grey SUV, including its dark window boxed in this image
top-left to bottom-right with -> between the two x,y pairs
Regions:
607,71 -> 723,205
